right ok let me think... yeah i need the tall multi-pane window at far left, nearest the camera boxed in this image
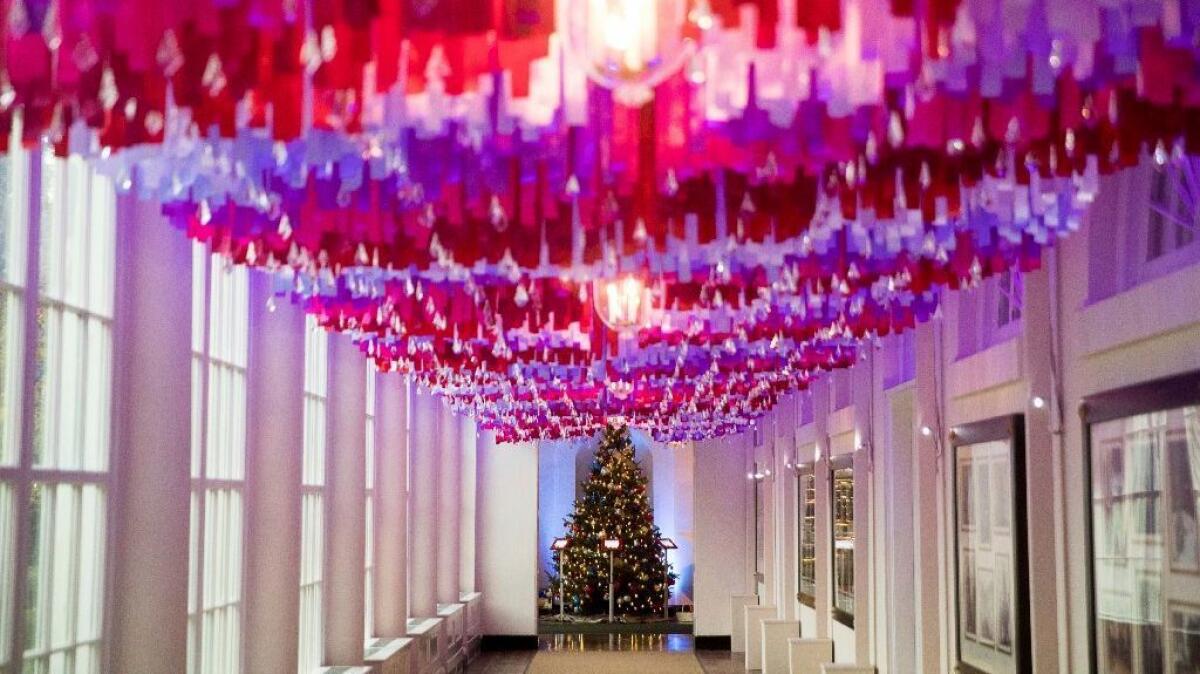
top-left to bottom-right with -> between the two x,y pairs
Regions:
0,144 -> 116,674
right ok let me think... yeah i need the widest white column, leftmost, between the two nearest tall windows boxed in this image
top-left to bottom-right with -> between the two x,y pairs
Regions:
108,191 -> 192,674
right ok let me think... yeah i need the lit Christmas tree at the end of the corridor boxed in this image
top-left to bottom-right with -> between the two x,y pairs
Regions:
554,426 -> 674,615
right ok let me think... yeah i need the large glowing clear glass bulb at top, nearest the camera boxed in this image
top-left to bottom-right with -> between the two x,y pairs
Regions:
565,0 -> 713,106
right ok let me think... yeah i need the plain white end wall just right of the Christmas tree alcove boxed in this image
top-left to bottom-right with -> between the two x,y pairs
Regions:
694,426 -> 754,636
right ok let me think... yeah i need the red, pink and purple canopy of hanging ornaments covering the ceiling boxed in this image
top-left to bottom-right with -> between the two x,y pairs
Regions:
0,0 -> 1200,440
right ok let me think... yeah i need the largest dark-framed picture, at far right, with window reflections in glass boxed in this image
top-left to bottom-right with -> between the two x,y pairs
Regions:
1081,373 -> 1200,674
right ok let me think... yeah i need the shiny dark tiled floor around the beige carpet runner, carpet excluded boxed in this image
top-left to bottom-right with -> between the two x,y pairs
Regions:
467,634 -> 745,674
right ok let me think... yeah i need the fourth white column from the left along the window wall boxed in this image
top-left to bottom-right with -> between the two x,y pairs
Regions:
374,374 -> 410,637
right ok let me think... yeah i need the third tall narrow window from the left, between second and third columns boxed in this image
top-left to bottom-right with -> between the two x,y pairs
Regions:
299,315 -> 329,674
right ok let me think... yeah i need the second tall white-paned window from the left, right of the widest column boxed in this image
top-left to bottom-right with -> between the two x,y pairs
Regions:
187,243 -> 250,674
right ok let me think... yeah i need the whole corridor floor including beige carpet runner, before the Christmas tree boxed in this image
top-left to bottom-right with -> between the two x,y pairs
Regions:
467,634 -> 745,674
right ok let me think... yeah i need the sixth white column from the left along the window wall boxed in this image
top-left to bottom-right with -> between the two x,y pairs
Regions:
437,402 -> 462,603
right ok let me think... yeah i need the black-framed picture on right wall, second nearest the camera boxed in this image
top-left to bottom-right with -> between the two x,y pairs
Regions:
950,416 -> 1031,674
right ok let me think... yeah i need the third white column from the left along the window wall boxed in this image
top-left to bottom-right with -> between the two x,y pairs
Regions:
325,335 -> 366,664
